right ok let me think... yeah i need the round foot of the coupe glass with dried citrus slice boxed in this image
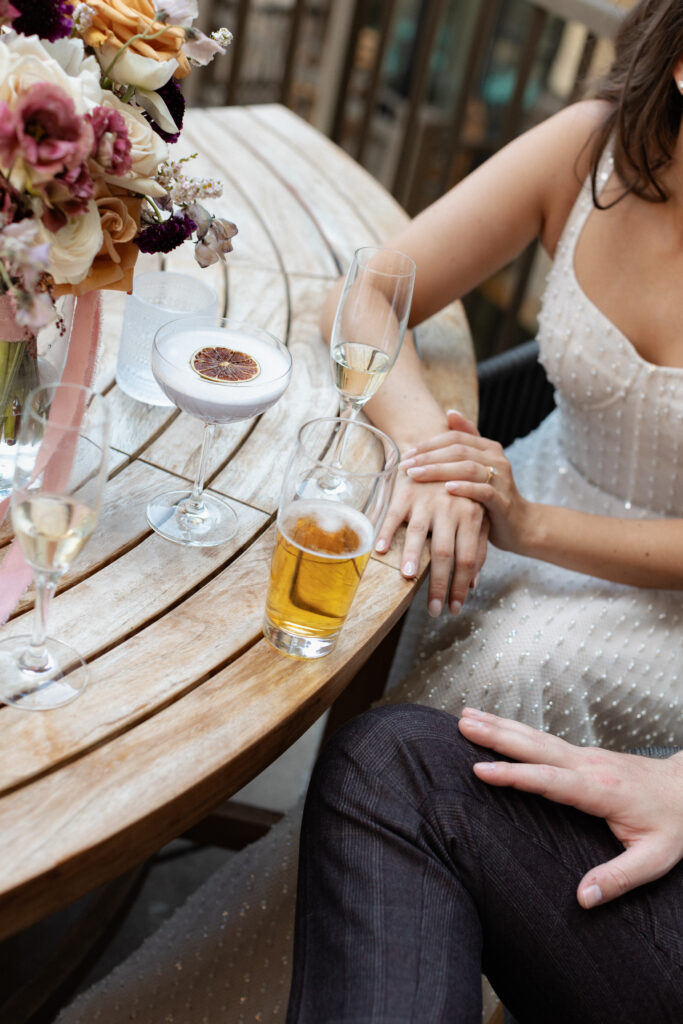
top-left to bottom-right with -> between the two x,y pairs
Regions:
147,490 -> 238,548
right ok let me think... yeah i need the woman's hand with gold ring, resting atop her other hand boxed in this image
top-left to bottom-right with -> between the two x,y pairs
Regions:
400,412 -> 535,551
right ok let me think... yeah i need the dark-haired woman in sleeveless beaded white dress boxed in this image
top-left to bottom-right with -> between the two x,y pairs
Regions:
324,0 -> 683,750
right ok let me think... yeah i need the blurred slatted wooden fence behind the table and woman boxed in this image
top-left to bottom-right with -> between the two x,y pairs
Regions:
186,0 -> 634,359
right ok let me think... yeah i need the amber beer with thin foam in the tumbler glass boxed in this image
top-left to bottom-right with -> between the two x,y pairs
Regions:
266,500 -> 375,646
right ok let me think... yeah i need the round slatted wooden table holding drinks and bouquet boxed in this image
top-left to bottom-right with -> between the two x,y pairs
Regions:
0,105 -> 476,938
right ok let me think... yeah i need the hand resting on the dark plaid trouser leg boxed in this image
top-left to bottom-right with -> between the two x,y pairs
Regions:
459,708 -> 683,909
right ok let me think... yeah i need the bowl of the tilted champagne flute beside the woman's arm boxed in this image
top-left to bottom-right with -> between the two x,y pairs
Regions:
330,246 -> 416,419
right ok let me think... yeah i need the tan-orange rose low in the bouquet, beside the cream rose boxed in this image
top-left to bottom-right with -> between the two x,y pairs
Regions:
54,181 -> 142,298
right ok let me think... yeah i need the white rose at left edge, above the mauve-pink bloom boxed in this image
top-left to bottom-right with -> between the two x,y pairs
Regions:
0,32 -> 102,115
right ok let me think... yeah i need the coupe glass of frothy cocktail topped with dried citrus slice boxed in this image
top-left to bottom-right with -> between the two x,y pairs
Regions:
147,316 -> 292,547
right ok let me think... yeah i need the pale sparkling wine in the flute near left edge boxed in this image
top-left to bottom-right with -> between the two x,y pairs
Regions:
12,493 -> 97,574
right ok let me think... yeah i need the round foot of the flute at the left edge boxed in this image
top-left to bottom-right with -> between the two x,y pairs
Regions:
0,635 -> 88,711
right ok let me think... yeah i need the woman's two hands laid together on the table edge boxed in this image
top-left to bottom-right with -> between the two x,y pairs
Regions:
377,411 -> 532,616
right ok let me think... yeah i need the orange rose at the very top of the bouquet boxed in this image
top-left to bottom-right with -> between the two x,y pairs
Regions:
83,0 -> 189,78
